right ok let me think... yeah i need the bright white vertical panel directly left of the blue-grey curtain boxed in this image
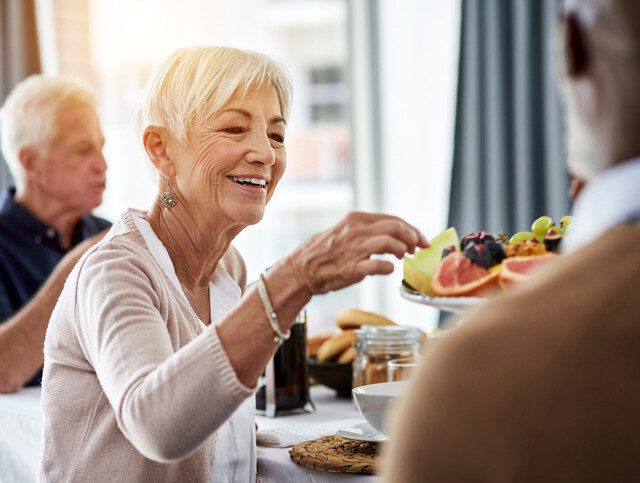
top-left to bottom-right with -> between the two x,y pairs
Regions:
379,0 -> 460,328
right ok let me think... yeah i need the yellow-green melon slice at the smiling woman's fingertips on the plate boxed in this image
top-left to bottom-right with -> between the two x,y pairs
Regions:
403,227 -> 460,295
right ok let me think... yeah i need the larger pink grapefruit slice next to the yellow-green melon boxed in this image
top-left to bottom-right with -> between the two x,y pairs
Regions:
431,252 -> 500,297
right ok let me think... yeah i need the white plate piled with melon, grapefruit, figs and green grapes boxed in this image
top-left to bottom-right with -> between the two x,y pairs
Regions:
400,216 -> 571,312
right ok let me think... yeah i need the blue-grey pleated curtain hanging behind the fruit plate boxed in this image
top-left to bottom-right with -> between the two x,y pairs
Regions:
449,0 -> 570,235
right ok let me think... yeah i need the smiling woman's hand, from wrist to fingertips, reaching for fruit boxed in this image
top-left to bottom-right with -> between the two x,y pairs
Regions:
284,212 -> 429,296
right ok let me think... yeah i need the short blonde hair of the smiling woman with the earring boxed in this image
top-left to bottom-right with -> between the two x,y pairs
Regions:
136,47 -> 292,146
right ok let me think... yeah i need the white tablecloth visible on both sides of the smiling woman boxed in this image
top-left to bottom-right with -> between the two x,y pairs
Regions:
0,386 -> 376,483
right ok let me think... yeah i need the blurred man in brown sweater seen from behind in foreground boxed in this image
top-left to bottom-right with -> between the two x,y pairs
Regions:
384,0 -> 640,482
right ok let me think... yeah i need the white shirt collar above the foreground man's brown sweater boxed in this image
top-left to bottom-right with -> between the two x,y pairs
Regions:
562,158 -> 640,252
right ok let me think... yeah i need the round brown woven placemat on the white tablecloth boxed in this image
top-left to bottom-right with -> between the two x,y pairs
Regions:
289,436 -> 380,475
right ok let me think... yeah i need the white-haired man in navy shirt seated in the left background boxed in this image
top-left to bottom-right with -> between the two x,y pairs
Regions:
0,76 -> 110,392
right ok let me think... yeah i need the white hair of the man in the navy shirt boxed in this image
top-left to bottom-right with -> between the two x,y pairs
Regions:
0,75 -> 96,188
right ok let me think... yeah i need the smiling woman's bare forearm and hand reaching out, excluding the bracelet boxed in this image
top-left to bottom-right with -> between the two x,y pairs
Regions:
216,213 -> 429,387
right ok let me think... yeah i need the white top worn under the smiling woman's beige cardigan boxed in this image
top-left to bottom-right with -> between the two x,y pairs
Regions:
133,216 -> 257,483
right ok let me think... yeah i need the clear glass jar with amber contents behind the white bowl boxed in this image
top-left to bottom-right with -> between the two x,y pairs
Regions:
353,325 -> 420,387
